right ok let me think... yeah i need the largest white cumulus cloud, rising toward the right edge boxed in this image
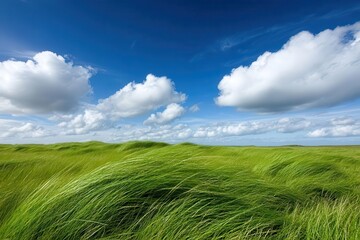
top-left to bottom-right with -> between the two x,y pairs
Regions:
216,22 -> 360,112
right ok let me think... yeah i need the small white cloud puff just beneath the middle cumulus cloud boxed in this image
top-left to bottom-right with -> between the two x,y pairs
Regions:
144,103 -> 185,125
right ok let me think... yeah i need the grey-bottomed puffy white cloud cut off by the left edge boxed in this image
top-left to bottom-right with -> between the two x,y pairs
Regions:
0,51 -> 92,114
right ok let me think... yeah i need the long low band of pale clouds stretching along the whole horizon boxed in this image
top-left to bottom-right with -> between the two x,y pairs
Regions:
0,112 -> 360,145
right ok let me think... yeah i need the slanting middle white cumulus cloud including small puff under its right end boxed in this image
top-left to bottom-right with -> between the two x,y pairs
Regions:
57,74 -> 186,134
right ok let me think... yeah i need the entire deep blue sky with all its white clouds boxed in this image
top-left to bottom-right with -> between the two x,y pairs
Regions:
0,0 -> 360,146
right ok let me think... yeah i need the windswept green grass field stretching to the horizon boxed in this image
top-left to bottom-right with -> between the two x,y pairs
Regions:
0,142 -> 360,240
